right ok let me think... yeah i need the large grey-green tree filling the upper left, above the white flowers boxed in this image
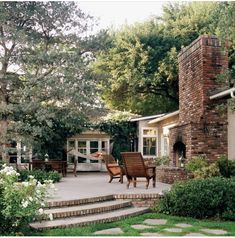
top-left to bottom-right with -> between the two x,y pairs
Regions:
0,2 -> 99,159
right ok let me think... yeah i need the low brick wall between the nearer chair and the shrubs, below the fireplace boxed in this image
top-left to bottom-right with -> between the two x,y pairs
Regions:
156,166 -> 190,184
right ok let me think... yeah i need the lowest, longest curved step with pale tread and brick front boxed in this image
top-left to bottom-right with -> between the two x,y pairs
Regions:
30,207 -> 149,230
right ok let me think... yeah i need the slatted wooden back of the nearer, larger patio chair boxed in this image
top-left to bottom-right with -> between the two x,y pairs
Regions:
121,152 -> 148,177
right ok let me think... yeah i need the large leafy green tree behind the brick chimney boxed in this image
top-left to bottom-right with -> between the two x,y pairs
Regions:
94,2 -> 222,115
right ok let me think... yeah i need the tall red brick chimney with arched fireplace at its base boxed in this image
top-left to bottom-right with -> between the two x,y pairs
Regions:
169,36 -> 228,166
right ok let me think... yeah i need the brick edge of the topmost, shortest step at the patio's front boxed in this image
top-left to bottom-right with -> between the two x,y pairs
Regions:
48,195 -> 114,208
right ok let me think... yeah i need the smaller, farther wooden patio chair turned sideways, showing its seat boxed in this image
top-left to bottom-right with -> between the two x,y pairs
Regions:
102,154 -> 124,183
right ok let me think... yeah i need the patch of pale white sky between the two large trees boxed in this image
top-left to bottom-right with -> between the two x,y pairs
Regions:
78,1 -> 166,31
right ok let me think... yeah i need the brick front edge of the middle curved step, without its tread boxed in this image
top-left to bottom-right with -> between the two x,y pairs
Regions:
44,202 -> 133,219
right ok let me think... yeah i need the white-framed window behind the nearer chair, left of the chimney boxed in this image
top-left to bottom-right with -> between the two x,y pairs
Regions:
142,128 -> 157,156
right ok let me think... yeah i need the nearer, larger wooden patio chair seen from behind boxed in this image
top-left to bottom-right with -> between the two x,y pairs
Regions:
121,152 -> 156,189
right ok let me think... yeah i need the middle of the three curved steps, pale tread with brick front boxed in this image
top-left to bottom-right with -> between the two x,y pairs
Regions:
44,200 -> 132,219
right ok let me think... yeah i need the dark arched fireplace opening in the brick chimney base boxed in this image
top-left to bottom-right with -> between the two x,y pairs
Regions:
173,141 -> 186,167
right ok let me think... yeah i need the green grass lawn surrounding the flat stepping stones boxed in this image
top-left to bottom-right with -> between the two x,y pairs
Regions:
27,213 -> 235,236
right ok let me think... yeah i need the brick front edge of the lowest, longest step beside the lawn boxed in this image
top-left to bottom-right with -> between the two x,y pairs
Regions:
34,208 -> 150,230
